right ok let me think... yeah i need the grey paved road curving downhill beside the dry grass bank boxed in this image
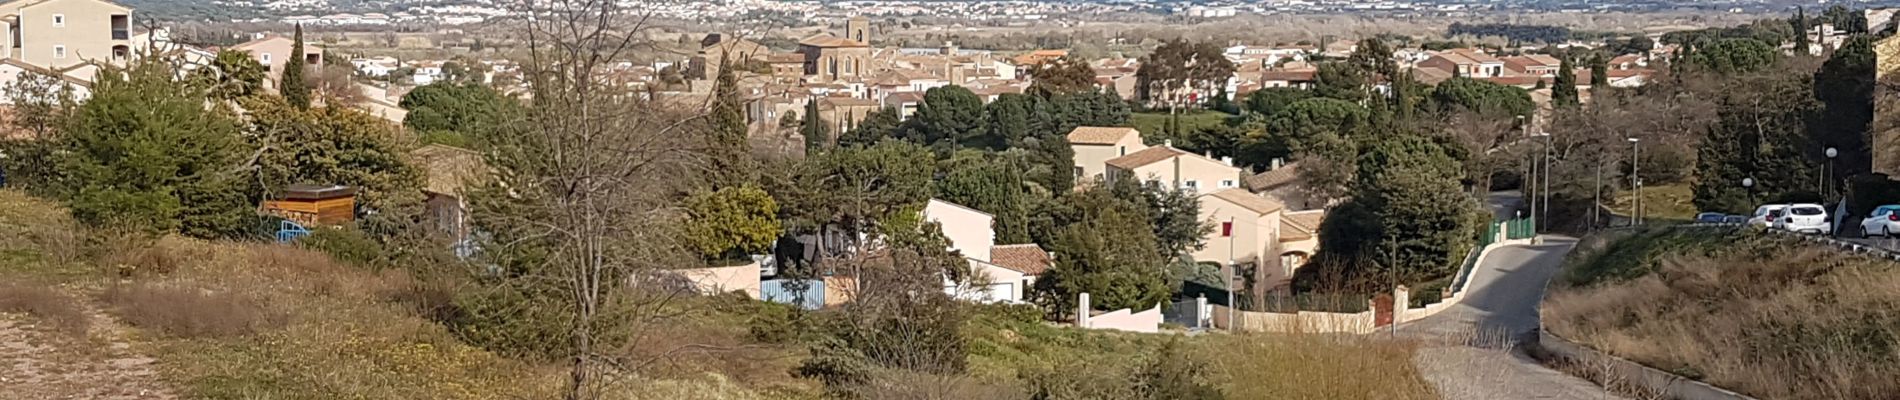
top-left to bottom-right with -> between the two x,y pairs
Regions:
1398,237 -> 1621,400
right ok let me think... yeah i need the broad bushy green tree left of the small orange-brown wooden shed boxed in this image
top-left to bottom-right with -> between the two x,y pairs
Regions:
57,59 -> 255,237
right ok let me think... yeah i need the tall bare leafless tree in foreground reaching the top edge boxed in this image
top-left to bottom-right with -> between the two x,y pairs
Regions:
473,0 -> 703,400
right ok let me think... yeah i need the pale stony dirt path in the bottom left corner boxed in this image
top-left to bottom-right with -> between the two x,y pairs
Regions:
0,313 -> 177,400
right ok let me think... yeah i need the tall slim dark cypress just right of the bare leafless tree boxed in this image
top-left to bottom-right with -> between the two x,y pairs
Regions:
707,57 -> 752,188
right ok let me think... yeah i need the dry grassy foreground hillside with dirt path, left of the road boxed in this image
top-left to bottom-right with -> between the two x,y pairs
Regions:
0,190 -> 1436,400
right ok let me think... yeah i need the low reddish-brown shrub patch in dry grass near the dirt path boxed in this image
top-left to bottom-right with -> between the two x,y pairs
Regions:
101,284 -> 283,337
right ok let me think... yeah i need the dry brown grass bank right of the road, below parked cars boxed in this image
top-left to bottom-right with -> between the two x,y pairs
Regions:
1545,234 -> 1900,398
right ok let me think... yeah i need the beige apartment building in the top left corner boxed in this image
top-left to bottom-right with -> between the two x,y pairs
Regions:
0,0 -> 131,69
